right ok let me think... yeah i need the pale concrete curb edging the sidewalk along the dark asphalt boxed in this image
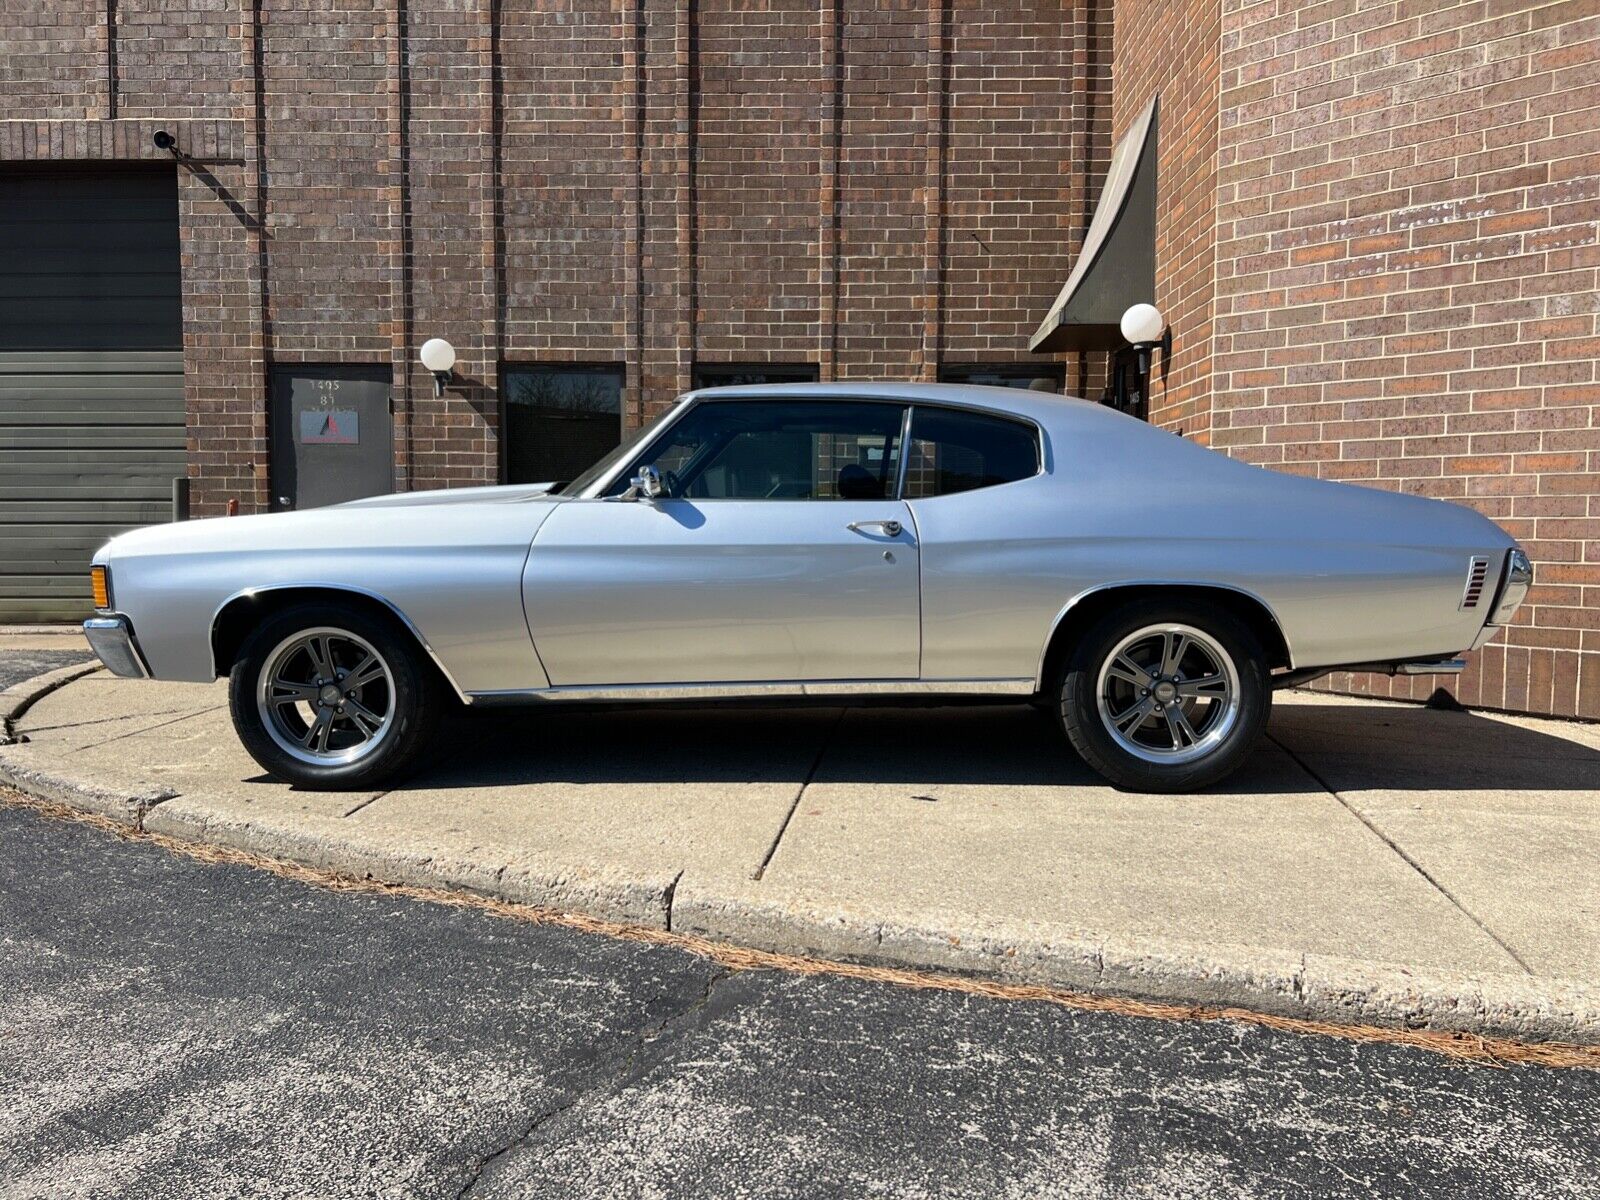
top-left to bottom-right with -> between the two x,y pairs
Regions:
0,666 -> 1600,1045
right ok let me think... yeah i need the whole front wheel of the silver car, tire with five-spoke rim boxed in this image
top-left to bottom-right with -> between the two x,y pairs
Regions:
229,602 -> 448,790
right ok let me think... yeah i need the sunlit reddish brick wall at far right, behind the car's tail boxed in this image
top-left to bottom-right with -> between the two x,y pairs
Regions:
1213,0 -> 1600,717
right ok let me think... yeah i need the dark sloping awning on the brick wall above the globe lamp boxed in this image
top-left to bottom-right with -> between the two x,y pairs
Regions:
1027,96 -> 1160,354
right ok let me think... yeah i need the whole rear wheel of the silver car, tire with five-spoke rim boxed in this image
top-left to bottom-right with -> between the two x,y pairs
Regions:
1058,598 -> 1272,792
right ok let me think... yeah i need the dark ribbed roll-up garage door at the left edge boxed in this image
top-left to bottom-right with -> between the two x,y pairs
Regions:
0,170 -> 187,621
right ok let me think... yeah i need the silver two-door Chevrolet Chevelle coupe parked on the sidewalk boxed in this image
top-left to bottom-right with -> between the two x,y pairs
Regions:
85,384 -> 1533,792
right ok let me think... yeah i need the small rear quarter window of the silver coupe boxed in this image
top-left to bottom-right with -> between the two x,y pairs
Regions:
906,406 -> 1038,499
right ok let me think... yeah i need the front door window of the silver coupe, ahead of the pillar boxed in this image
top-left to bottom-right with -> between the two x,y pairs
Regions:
618,400 -> 906,499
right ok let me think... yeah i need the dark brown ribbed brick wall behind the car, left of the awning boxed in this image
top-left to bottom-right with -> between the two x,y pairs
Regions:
0,0 -> 1109,514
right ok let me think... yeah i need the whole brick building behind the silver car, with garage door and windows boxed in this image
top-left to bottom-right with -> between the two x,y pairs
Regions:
0,0 -> 1600,717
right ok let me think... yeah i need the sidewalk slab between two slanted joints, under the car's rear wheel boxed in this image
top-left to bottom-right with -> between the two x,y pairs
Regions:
742,709 -> 1518,971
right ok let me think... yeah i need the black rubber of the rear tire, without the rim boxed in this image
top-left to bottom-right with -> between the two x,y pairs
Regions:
1058,600 -> 1272,792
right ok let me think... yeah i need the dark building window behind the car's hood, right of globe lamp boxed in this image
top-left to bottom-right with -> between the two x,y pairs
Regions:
501,366 -> 622,483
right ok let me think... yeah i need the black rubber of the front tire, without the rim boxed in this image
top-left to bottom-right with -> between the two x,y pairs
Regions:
227,603 -> 434,790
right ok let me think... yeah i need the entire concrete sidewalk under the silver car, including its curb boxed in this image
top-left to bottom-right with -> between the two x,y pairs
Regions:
0,642 -> 1600,1042
